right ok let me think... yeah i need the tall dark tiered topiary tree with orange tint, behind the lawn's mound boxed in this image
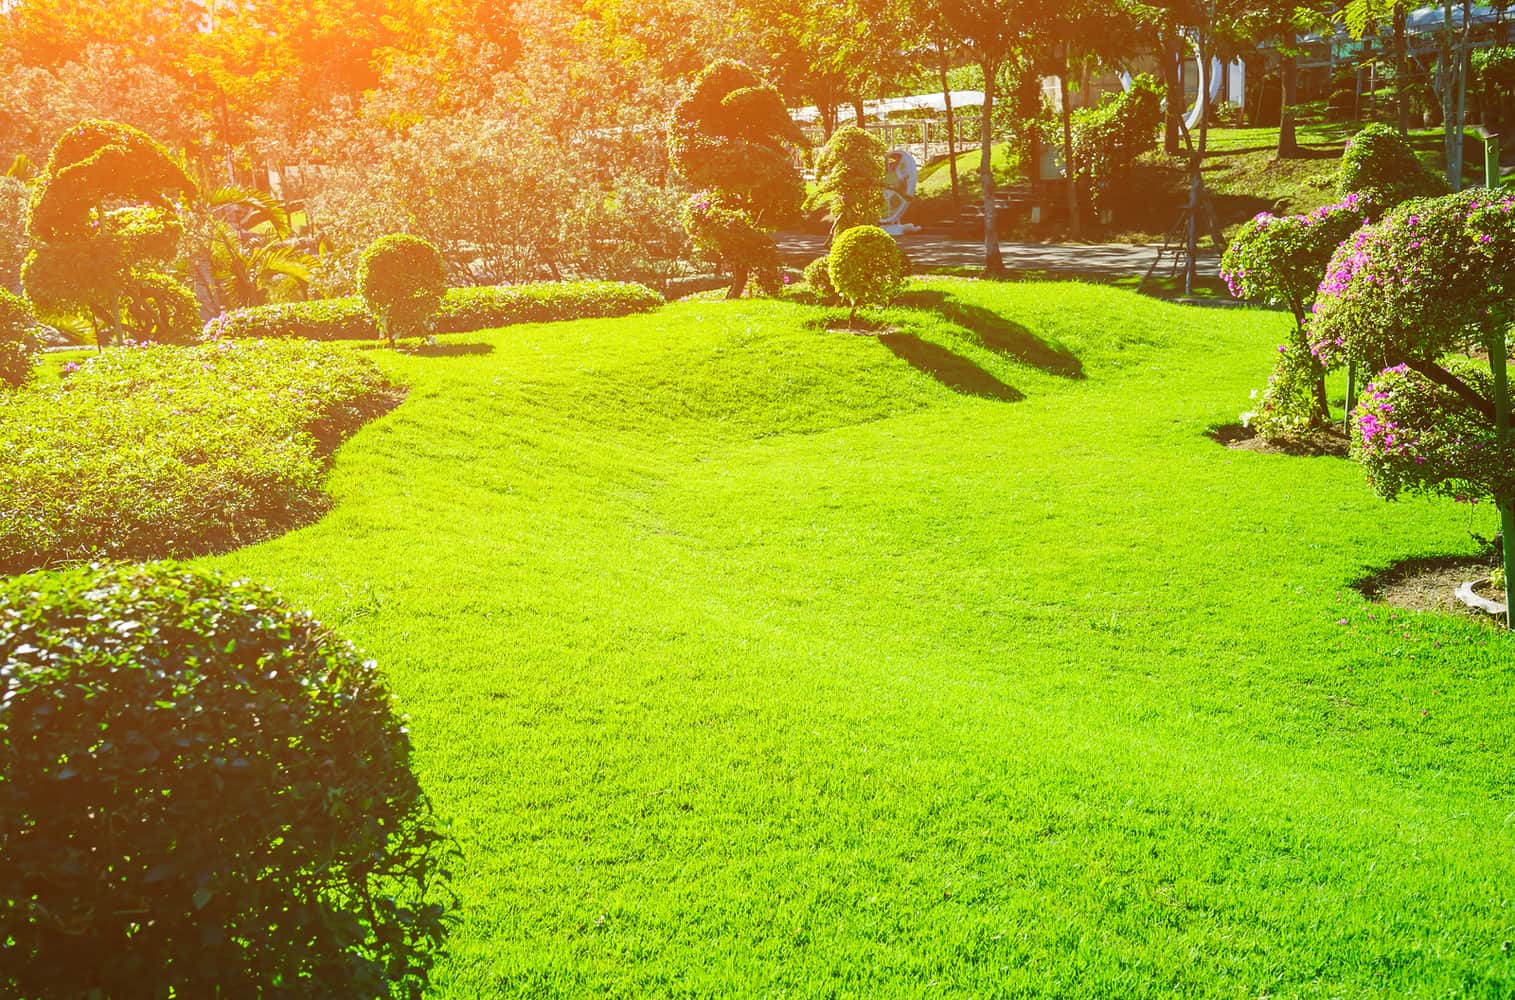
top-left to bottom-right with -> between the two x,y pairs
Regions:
668,59 -> 805,298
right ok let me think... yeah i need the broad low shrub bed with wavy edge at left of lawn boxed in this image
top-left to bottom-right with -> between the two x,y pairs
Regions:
0,341 -> 397,573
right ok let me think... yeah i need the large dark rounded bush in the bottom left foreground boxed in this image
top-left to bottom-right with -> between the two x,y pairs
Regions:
0,564 -> 450,997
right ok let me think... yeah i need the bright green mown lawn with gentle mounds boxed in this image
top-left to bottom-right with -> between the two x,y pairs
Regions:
206,279 -> 1515,1000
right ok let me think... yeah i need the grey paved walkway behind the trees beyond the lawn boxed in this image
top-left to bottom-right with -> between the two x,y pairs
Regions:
779,232 -> 1220,277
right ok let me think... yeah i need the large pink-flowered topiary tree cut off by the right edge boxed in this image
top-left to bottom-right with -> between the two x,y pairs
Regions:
1309,189 -> 1515,624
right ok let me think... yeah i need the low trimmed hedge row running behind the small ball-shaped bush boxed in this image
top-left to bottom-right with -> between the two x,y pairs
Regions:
201,282 -> 664,341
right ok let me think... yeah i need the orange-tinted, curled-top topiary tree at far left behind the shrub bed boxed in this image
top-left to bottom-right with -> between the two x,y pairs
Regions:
21,121 -> 194,347
